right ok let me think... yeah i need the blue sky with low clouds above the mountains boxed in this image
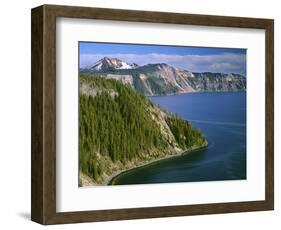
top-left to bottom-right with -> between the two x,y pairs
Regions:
79,42 -> 246,75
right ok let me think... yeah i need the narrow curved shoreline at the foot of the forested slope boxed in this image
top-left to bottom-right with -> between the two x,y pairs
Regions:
106,143 -> 208,185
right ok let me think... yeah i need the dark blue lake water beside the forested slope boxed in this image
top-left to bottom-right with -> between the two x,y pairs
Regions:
113,92 -> 246,184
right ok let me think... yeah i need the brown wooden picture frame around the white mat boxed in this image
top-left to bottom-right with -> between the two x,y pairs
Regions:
31,5 -> 274,224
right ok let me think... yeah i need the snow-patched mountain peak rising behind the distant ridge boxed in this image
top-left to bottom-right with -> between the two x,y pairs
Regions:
90,57 -> 138,72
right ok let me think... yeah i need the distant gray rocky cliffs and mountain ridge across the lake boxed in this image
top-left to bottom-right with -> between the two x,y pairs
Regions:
80,58 -> 246,96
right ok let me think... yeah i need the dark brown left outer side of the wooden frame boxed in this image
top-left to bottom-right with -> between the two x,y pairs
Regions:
31,7 -> 44,223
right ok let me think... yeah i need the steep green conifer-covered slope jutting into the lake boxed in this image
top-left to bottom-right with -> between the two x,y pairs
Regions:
79,76 -> 207,186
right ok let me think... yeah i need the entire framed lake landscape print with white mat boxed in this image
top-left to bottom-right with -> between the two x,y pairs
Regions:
31,5 -> 274,224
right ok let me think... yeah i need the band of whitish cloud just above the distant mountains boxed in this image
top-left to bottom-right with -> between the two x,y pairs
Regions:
80,53 -> 246,74
